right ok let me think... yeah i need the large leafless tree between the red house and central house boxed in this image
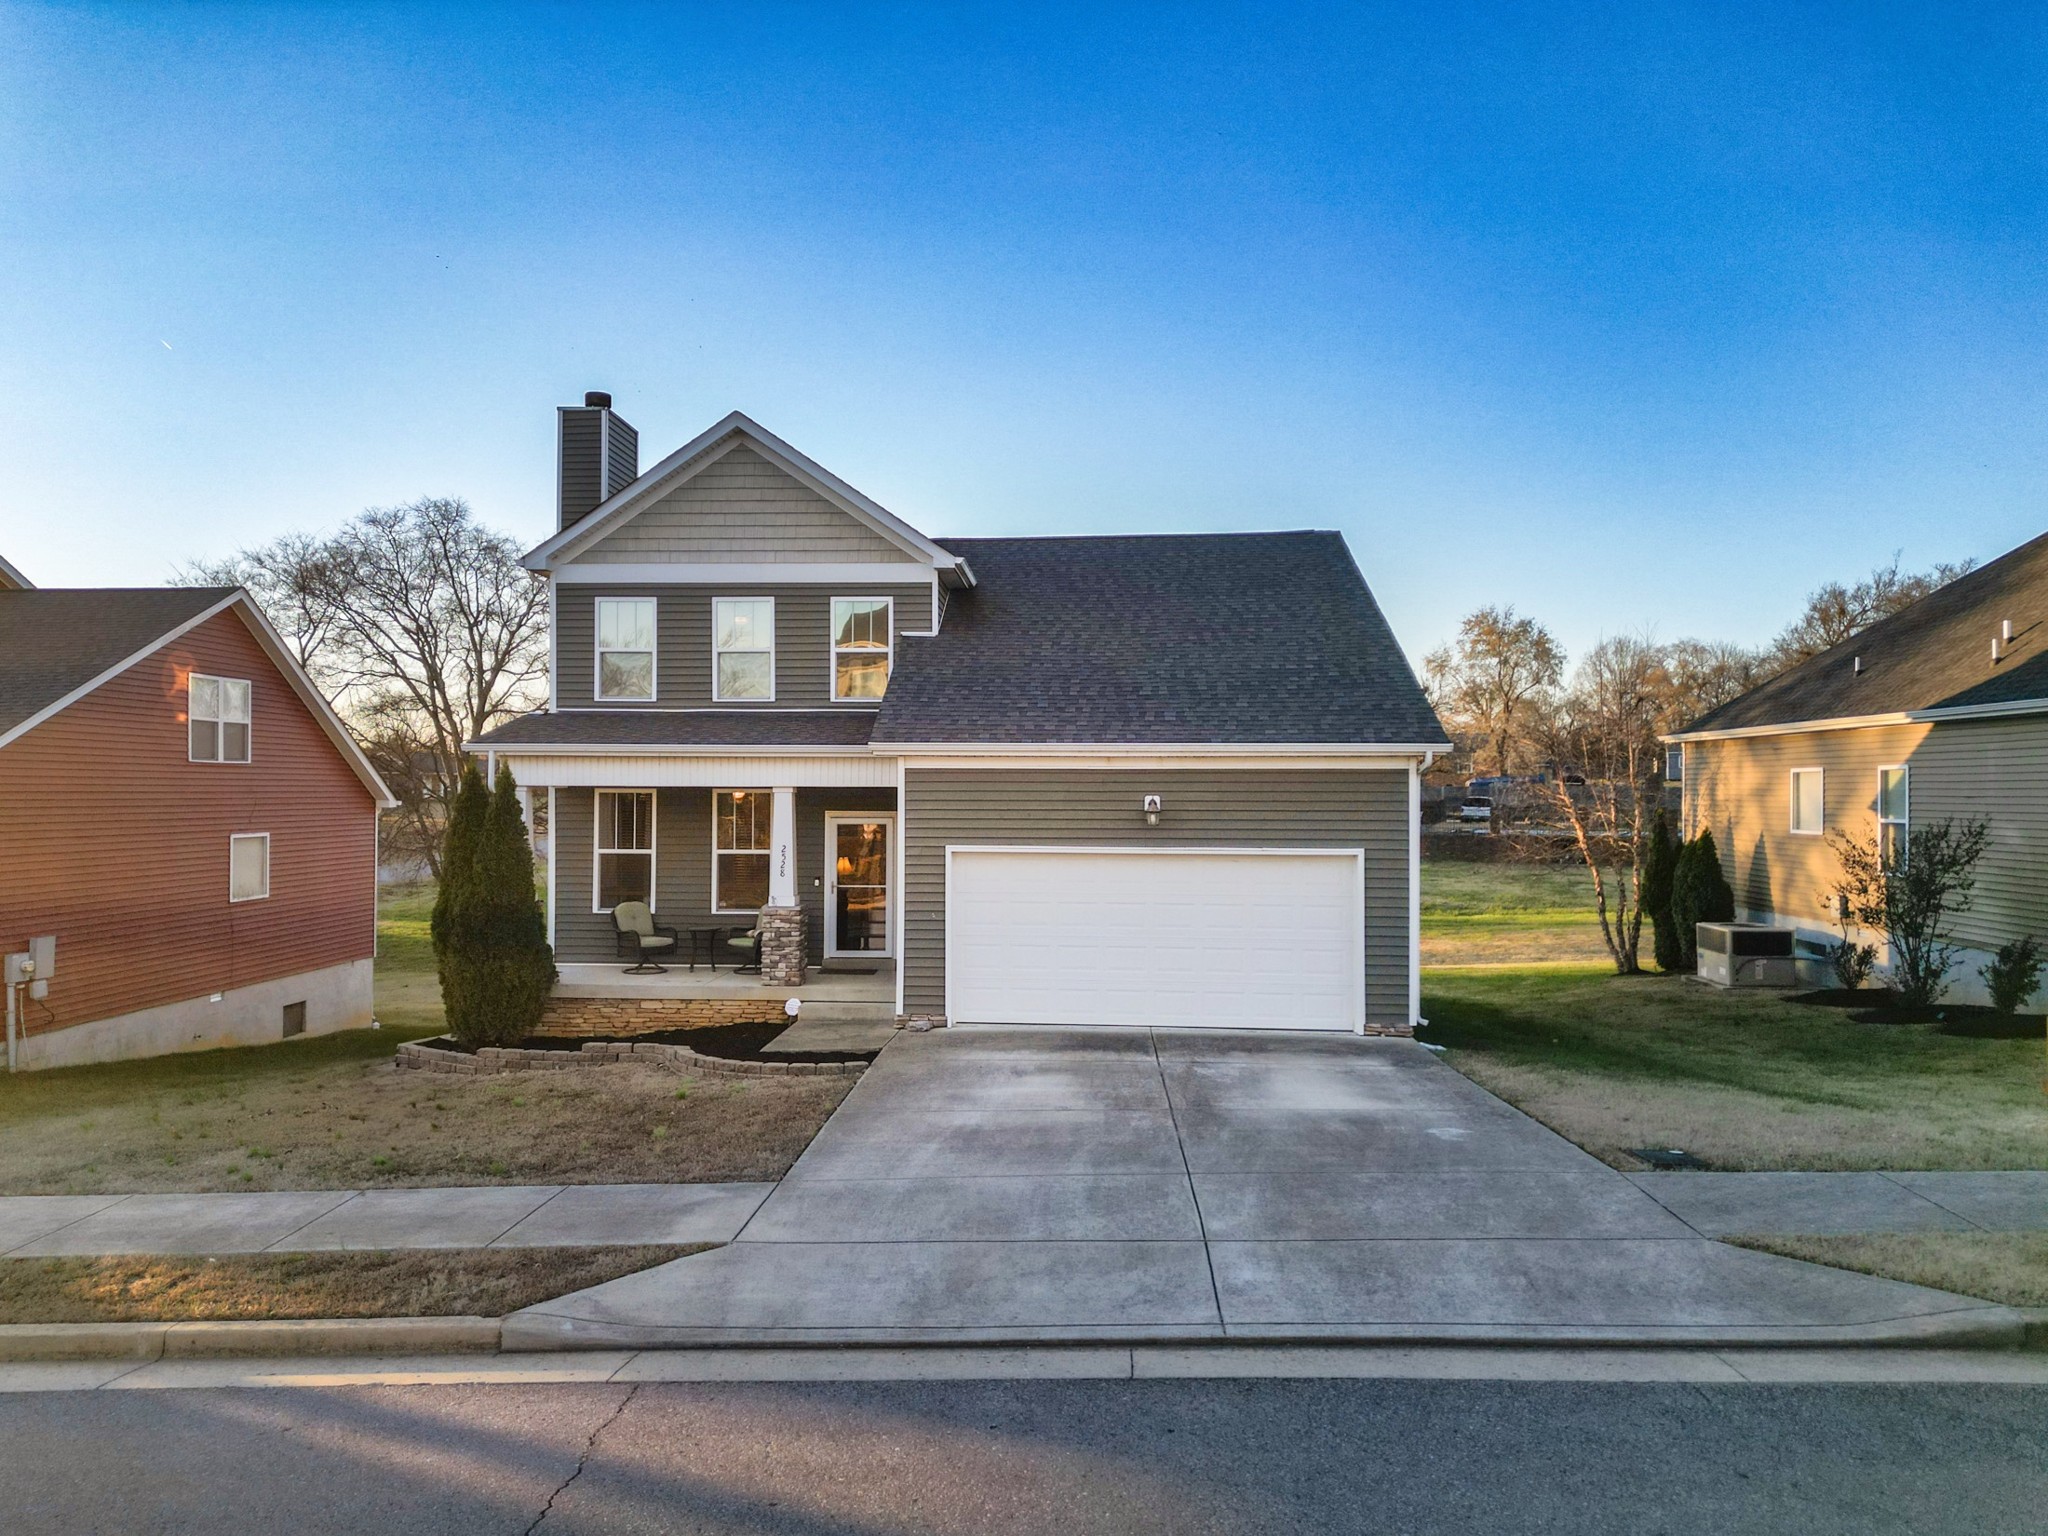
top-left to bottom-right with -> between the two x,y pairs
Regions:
180,496 -> 547,872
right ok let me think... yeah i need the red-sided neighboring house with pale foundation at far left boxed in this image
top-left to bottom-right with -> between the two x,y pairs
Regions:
0,561 -> 391,1067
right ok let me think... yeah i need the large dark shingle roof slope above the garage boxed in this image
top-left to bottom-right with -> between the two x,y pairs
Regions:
872,532 -> 1448,745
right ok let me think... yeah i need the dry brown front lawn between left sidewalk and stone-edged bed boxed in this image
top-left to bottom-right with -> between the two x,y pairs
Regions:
0,1056 -> 854,1194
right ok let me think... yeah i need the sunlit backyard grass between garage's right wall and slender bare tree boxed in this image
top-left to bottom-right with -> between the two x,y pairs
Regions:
1421,848 -> 1608,965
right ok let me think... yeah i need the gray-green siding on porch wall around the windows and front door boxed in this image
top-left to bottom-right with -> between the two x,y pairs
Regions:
553,784 -> 895,965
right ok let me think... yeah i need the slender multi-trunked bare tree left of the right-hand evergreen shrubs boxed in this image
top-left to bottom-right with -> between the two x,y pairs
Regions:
1540,635 -> 1671,975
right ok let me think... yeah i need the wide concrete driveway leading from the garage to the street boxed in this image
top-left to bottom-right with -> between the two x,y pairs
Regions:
506,1030 -> 2015,1348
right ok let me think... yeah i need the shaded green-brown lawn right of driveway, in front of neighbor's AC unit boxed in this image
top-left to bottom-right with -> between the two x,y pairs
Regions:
1421,967 -> 2048,1169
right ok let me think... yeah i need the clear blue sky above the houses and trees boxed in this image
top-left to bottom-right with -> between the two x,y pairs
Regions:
0,4 -> 2048,657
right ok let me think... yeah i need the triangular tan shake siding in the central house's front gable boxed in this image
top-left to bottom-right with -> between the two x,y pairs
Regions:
575,446 -> 918,565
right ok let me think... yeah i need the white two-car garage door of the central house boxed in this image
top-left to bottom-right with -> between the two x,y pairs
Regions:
946,848 -> 1366,1030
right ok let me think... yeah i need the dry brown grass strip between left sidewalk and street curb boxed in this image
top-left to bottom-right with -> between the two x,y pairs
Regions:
0,1245 -> 707,1323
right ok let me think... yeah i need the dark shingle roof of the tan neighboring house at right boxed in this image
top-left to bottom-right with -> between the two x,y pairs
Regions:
1679,535 -> 2048,735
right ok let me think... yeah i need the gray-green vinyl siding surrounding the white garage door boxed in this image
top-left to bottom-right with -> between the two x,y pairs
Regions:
901,766 -> 1413,1024
